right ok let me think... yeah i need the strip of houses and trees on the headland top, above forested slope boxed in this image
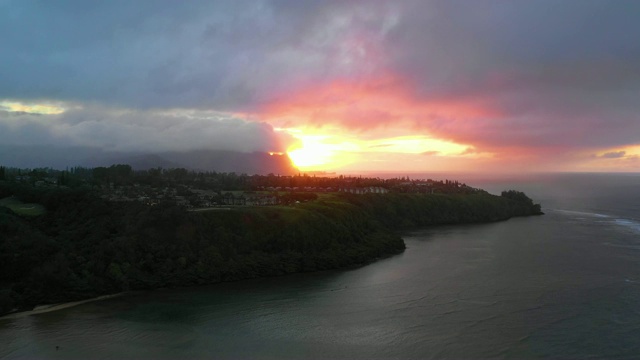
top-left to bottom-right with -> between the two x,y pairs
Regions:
0,165 -> 482,209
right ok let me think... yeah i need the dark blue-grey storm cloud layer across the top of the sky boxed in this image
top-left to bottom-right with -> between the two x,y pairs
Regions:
0,0 -> 640,111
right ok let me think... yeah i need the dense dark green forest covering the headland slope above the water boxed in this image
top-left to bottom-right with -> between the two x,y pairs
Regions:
0,181 -> 540,313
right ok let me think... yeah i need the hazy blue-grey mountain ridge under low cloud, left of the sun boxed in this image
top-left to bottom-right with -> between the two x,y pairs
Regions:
0,145 -> 297,174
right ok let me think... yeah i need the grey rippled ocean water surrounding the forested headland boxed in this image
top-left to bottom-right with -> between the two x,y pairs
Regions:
0,174 -> 640,359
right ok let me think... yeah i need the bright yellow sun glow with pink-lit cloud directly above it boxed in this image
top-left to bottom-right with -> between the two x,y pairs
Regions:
259,74 -> 501,171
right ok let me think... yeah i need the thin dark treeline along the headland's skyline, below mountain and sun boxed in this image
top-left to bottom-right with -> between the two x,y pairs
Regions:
0,164 -> 481,193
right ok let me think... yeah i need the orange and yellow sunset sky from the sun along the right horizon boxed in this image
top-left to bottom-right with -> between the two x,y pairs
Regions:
254,73 -> 640,172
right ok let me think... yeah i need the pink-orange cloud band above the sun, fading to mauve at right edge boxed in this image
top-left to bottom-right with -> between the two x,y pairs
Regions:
258,74 -> 640,158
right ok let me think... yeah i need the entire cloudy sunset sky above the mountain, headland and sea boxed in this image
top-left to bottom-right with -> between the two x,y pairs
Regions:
0,0 -> 640,172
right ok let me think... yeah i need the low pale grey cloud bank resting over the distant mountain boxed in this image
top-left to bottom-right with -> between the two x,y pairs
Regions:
0,106 -> 292,152
